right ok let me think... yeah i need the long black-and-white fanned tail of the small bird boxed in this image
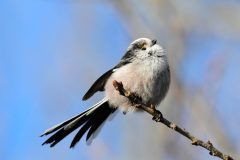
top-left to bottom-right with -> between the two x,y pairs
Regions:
41,99 -> 116,148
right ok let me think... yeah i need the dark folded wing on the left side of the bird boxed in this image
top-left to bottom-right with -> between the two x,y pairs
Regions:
82,55 -> 131,100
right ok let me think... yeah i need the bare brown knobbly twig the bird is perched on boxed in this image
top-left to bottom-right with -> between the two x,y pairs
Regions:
113,80 -> 234,160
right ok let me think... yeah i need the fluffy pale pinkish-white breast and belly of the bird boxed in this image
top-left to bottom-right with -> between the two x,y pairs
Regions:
105,59 -> 169,110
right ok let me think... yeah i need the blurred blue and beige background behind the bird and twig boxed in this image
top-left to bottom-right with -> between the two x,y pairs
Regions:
0,0 -> 240,160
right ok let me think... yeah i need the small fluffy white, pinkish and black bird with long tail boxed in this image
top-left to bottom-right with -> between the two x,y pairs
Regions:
41,38 -> 170,148
